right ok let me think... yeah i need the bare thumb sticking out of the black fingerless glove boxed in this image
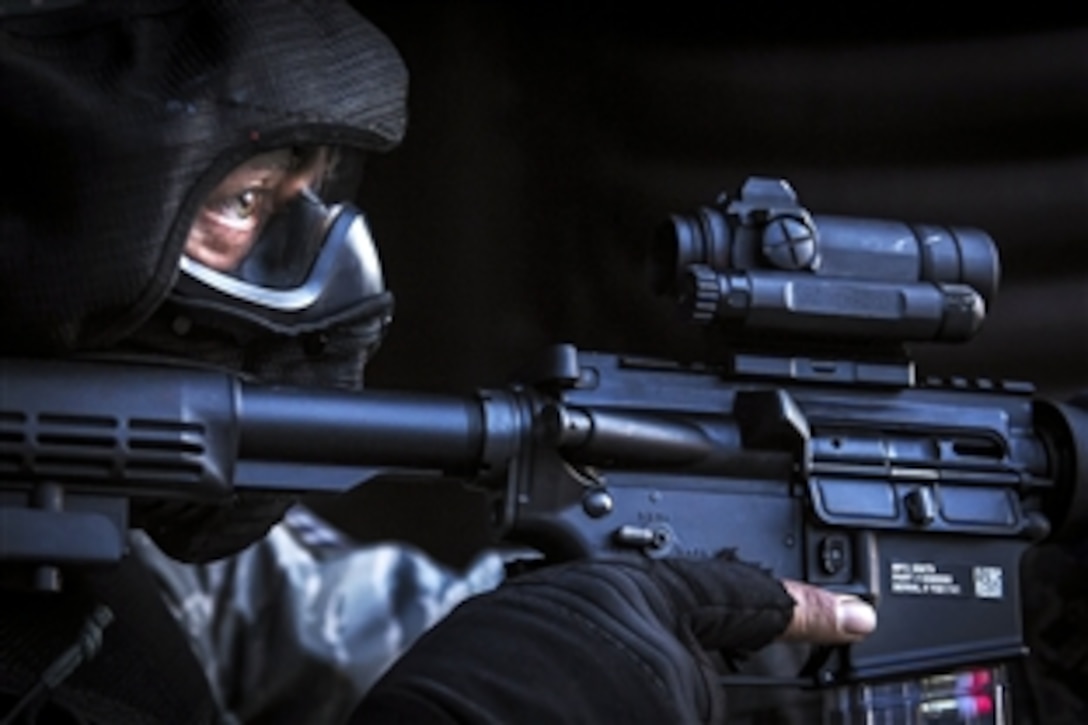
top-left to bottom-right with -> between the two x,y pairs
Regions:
781,579 -> 877,644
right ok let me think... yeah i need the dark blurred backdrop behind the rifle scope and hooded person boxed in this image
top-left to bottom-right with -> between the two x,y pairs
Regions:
306,7 -> 1088,562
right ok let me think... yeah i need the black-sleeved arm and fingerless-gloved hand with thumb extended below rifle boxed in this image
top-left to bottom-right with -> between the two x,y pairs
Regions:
351,550 -> 876,723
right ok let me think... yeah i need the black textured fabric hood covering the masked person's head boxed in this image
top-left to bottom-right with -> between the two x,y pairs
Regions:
0,0 -> 408,354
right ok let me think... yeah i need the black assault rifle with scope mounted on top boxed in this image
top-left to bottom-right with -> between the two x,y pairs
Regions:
0,179 -> 1088,684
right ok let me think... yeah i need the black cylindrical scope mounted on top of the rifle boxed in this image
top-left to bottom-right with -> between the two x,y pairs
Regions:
650,176 -> 1000,345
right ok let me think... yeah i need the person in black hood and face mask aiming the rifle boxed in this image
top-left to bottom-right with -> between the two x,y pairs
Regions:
0,0 -> 875,723
